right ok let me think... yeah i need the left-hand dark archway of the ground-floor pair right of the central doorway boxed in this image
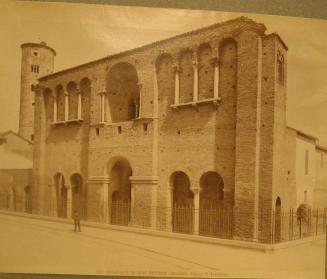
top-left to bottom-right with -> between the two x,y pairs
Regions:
170,171 -> 194,233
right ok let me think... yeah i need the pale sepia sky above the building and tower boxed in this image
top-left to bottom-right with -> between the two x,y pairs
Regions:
0,0 -> 327,145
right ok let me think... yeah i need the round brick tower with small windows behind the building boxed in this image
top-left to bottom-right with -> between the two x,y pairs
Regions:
19,42 -> 56,141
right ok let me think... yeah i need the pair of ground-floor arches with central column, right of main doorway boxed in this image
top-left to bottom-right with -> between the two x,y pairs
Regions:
170,171 -> 232,236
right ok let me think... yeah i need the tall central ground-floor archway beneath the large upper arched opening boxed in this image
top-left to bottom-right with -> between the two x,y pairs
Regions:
109,159 -> 132,226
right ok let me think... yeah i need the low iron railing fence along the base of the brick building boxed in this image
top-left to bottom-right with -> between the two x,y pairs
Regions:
3,201 -> 327,243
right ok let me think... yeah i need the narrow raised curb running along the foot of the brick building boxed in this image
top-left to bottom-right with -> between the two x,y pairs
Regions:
0,210 -> 325,252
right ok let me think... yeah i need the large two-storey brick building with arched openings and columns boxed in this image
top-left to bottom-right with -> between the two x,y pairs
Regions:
18,17 -> 325,241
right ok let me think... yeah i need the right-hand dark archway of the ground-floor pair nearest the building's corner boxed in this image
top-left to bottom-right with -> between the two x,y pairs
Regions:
199,171 -> 229,236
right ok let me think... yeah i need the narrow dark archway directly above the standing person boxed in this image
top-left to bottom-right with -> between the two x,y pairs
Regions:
70,173 -> 85,219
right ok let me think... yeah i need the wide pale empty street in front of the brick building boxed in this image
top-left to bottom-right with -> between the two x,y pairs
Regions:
0,214 -> 325,279
